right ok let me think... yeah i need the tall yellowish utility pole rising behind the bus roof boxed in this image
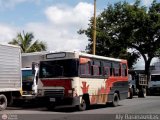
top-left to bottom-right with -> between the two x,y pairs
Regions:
93,0 -> 96,55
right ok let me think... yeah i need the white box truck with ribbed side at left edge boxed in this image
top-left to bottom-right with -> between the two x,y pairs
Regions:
0,44 -> 22,110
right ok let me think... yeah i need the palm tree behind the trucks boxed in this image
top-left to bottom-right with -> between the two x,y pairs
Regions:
9,32 -> 47,53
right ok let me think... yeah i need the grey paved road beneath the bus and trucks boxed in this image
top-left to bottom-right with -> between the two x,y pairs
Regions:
0,96 -> 160,120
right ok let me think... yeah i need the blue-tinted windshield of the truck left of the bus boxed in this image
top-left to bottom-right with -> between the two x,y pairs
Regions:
22,70 -> 33,82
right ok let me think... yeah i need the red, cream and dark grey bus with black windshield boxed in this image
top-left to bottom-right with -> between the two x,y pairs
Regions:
37,52 -> 128,111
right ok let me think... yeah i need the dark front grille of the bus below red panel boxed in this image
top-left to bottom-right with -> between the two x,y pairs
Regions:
44,89 -> 64,97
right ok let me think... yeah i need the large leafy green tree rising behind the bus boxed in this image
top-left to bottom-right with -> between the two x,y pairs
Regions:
79,0 -> 160,80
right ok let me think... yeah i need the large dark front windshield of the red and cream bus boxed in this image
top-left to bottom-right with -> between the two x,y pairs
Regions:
39,59 -> 78,78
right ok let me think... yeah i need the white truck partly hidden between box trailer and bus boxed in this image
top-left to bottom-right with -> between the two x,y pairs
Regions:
20,52 -> 46,100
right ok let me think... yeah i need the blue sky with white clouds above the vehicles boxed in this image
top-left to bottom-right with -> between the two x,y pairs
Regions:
0,0 -> 160,68
